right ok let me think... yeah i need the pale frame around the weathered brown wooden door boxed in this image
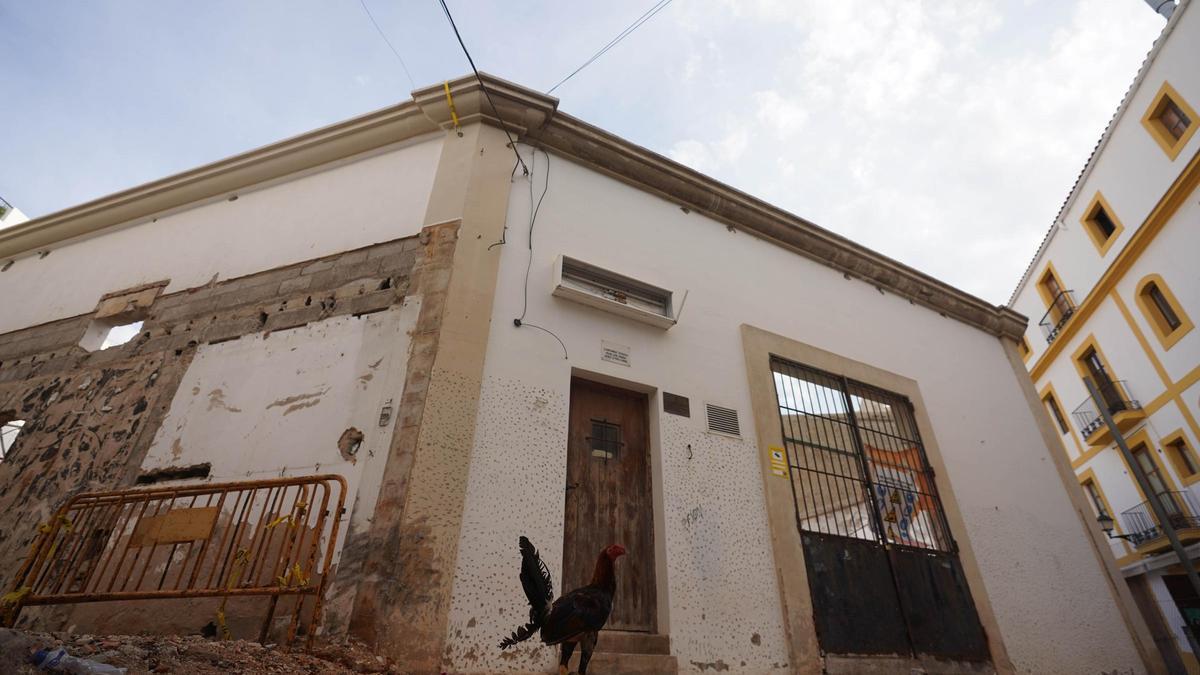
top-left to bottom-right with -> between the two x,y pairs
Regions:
563,366 -> 671,635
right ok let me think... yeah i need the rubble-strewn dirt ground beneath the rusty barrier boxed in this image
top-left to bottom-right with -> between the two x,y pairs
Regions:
0,628 -> 400,675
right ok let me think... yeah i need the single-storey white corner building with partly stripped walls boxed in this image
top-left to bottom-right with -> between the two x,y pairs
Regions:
0,77 -> 1162,674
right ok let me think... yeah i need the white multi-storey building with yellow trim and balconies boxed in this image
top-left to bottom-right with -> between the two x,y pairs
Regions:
1012,1 -> 1200,673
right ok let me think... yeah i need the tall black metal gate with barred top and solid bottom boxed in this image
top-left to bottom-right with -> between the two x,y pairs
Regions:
770,357 -> 990,661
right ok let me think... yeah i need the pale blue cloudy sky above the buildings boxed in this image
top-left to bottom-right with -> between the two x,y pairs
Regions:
0,0 -> 1164,304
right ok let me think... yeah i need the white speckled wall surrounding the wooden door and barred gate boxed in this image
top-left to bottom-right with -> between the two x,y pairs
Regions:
448,154 -> 1141,673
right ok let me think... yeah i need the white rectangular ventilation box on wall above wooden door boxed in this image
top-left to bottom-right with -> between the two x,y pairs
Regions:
552,256 -> 682,329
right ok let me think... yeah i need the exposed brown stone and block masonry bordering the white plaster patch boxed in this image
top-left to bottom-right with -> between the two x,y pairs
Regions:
0,233 -> 430,605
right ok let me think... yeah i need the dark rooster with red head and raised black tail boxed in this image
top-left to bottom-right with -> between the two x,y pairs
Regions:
500,537 -> 625,675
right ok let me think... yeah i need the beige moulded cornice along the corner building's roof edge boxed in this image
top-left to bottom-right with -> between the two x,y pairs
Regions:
0,73 -> 1027,340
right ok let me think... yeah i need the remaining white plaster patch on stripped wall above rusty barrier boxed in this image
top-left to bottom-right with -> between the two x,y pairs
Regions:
142,305 -> 420,562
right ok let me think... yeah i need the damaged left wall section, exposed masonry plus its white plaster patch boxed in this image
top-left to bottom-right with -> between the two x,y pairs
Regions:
0,228 -> 429,632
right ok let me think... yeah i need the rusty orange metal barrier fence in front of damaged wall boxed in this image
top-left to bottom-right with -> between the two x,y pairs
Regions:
0,474 -> 346,649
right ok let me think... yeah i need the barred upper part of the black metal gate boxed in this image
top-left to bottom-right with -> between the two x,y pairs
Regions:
770,357 -> 956,551
